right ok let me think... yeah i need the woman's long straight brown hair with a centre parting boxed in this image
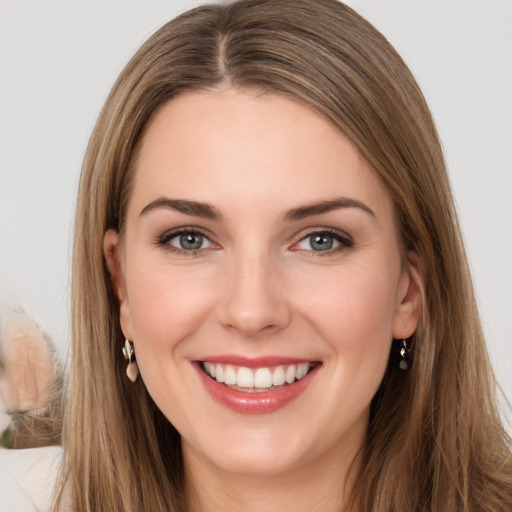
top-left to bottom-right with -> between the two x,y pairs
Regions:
55,0 -> 512,512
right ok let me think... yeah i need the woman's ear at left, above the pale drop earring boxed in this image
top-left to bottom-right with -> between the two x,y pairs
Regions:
103,229 -> 133,340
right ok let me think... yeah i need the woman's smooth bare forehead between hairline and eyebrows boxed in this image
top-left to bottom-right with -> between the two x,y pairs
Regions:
133,89 -> 390,221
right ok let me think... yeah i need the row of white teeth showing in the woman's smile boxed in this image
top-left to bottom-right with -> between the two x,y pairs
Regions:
201,361 -> 319,393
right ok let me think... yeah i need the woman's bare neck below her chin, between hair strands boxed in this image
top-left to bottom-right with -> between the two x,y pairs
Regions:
184,436 -> 359,512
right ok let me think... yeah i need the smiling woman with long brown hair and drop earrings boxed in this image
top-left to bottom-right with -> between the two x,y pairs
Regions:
44,0 -> 512,512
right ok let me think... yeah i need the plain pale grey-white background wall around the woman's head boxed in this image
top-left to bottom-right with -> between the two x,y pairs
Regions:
0,0 -> 512,424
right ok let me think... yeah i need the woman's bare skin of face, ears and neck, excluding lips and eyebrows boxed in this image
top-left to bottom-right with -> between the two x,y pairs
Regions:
105,89 -> 421,512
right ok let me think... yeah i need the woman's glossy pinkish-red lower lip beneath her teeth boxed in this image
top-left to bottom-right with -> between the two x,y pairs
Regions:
195,363 -> 321,414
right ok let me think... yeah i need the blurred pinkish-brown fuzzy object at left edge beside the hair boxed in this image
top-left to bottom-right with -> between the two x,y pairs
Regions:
0,307 -> 62,448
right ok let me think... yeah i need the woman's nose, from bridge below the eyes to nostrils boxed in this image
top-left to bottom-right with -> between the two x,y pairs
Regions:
218,249 -> 291,338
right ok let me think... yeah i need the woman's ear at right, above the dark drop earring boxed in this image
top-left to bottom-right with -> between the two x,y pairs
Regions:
393,251 -> 423,339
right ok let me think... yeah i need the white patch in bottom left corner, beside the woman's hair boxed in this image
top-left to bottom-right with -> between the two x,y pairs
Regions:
0,446 -> 62,512
